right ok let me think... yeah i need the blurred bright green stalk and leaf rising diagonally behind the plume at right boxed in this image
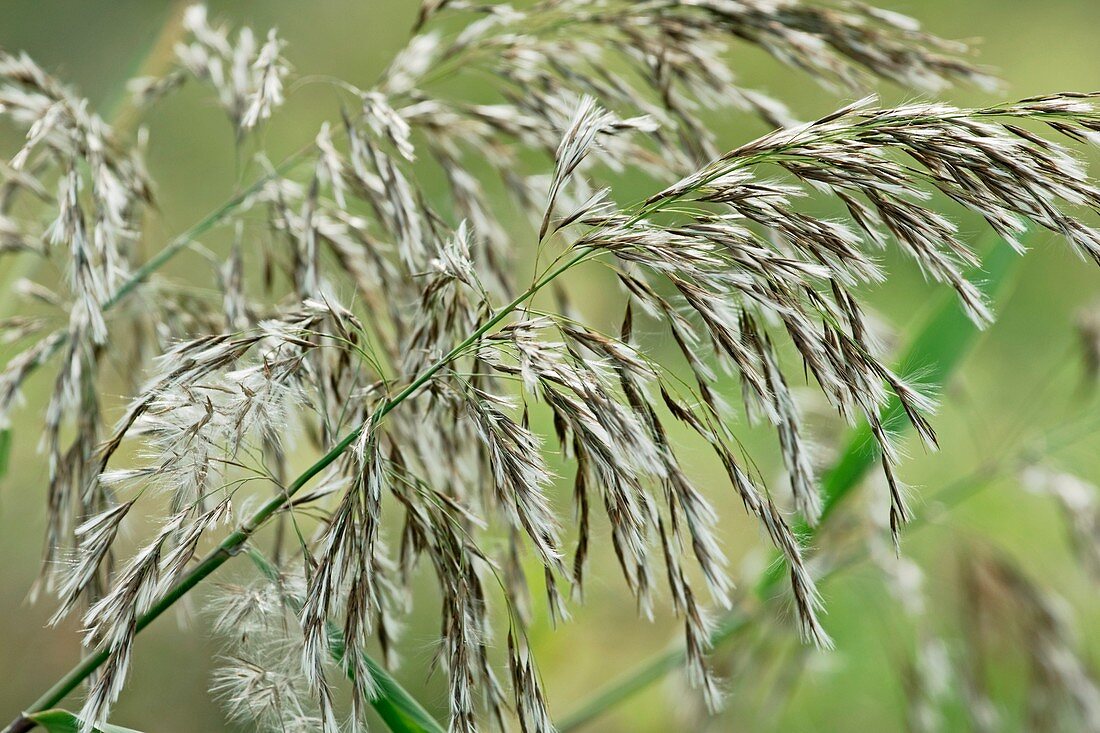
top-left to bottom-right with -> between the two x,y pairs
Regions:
558,235 -> 1022,733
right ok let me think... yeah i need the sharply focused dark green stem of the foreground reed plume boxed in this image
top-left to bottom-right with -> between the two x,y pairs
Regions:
3,246 -> 592,733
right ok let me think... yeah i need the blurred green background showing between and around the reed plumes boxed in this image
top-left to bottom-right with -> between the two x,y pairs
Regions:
0,0 -> 1100,733
